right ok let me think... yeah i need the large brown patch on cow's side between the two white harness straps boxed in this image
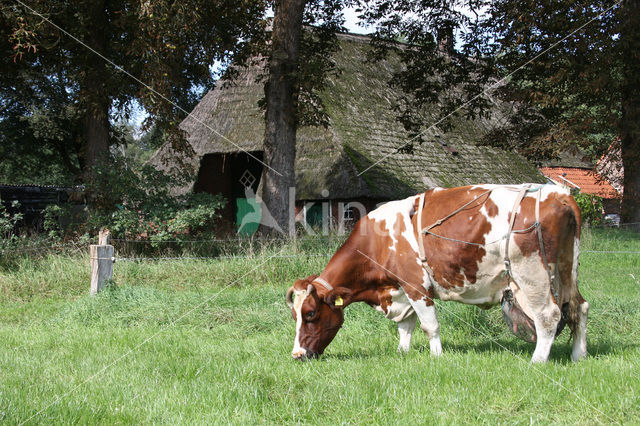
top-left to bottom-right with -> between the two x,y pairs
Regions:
413,186 -> 498,289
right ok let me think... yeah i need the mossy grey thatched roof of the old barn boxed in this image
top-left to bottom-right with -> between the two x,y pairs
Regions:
152,34 -> 544,199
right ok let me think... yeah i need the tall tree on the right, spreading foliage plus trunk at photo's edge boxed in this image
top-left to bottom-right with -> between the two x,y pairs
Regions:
360,0 -> 640,226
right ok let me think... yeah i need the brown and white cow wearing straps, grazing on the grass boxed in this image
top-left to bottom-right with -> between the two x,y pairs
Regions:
285,184 -> 589,362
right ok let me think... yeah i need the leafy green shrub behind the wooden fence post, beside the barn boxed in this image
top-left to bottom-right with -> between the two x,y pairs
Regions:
46,158 -> 226,242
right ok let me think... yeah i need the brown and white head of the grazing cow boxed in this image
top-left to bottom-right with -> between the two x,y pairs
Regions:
286,275 -> 352,359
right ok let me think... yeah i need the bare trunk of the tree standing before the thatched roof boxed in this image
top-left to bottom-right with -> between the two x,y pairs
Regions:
261,0 -> 306,233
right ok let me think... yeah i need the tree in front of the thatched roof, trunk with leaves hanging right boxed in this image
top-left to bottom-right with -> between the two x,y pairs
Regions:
262,0 -> 351,235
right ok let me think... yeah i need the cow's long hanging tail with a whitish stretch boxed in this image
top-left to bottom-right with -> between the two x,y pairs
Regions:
563,197 -> 584,338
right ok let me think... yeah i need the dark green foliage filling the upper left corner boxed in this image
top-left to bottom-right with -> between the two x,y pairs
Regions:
0,0 -> 268,184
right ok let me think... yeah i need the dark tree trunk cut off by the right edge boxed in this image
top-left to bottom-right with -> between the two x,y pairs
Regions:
620,0 -> 640,231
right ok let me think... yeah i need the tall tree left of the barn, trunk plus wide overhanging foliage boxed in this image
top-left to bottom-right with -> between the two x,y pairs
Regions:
0,0 -> 267,190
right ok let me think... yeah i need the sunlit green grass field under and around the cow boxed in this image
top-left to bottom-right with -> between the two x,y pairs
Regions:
0,230 -> 640,424
